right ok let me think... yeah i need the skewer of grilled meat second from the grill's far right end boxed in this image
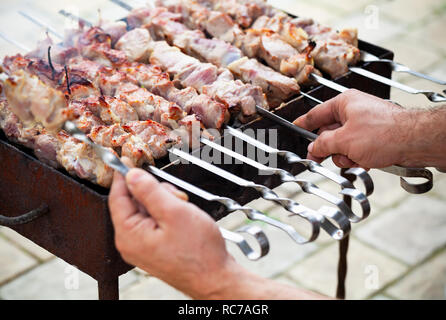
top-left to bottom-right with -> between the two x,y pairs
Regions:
143,1 -> 320,85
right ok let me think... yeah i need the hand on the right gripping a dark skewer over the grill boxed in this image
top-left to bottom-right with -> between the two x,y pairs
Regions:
294,89 -> 416,168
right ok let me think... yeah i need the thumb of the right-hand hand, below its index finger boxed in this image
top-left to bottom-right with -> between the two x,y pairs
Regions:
308,128 -> 347,158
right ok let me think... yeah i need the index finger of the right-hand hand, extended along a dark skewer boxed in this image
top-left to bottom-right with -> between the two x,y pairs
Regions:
293,96 -> 340,131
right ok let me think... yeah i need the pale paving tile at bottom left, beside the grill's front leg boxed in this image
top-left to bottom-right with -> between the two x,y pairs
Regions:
0,258 -> 138,300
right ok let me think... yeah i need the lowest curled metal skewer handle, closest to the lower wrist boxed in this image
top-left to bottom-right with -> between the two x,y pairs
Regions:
219,226 -> 269,261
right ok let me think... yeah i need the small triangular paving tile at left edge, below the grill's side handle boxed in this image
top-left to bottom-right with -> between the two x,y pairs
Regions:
0,237 -> 37,284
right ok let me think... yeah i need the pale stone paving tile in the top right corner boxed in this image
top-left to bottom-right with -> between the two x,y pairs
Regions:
380,0 -> 443,24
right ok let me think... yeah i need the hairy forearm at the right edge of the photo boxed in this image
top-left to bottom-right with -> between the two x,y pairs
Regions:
401,106 -> 446,169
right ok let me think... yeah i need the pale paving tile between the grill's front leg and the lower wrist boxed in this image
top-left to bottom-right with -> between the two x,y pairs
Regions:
121,277 -> 190,300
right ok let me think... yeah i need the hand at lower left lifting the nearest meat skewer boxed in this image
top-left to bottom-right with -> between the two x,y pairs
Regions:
109,160 -> 237,298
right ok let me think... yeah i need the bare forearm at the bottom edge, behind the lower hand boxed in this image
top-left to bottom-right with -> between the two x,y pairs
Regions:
191,261 -> 330,300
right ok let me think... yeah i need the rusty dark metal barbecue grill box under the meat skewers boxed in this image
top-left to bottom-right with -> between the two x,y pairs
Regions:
0,0 -> 440,299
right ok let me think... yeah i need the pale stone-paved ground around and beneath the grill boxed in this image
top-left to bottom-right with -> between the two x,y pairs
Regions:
0,0 -> 446,299
